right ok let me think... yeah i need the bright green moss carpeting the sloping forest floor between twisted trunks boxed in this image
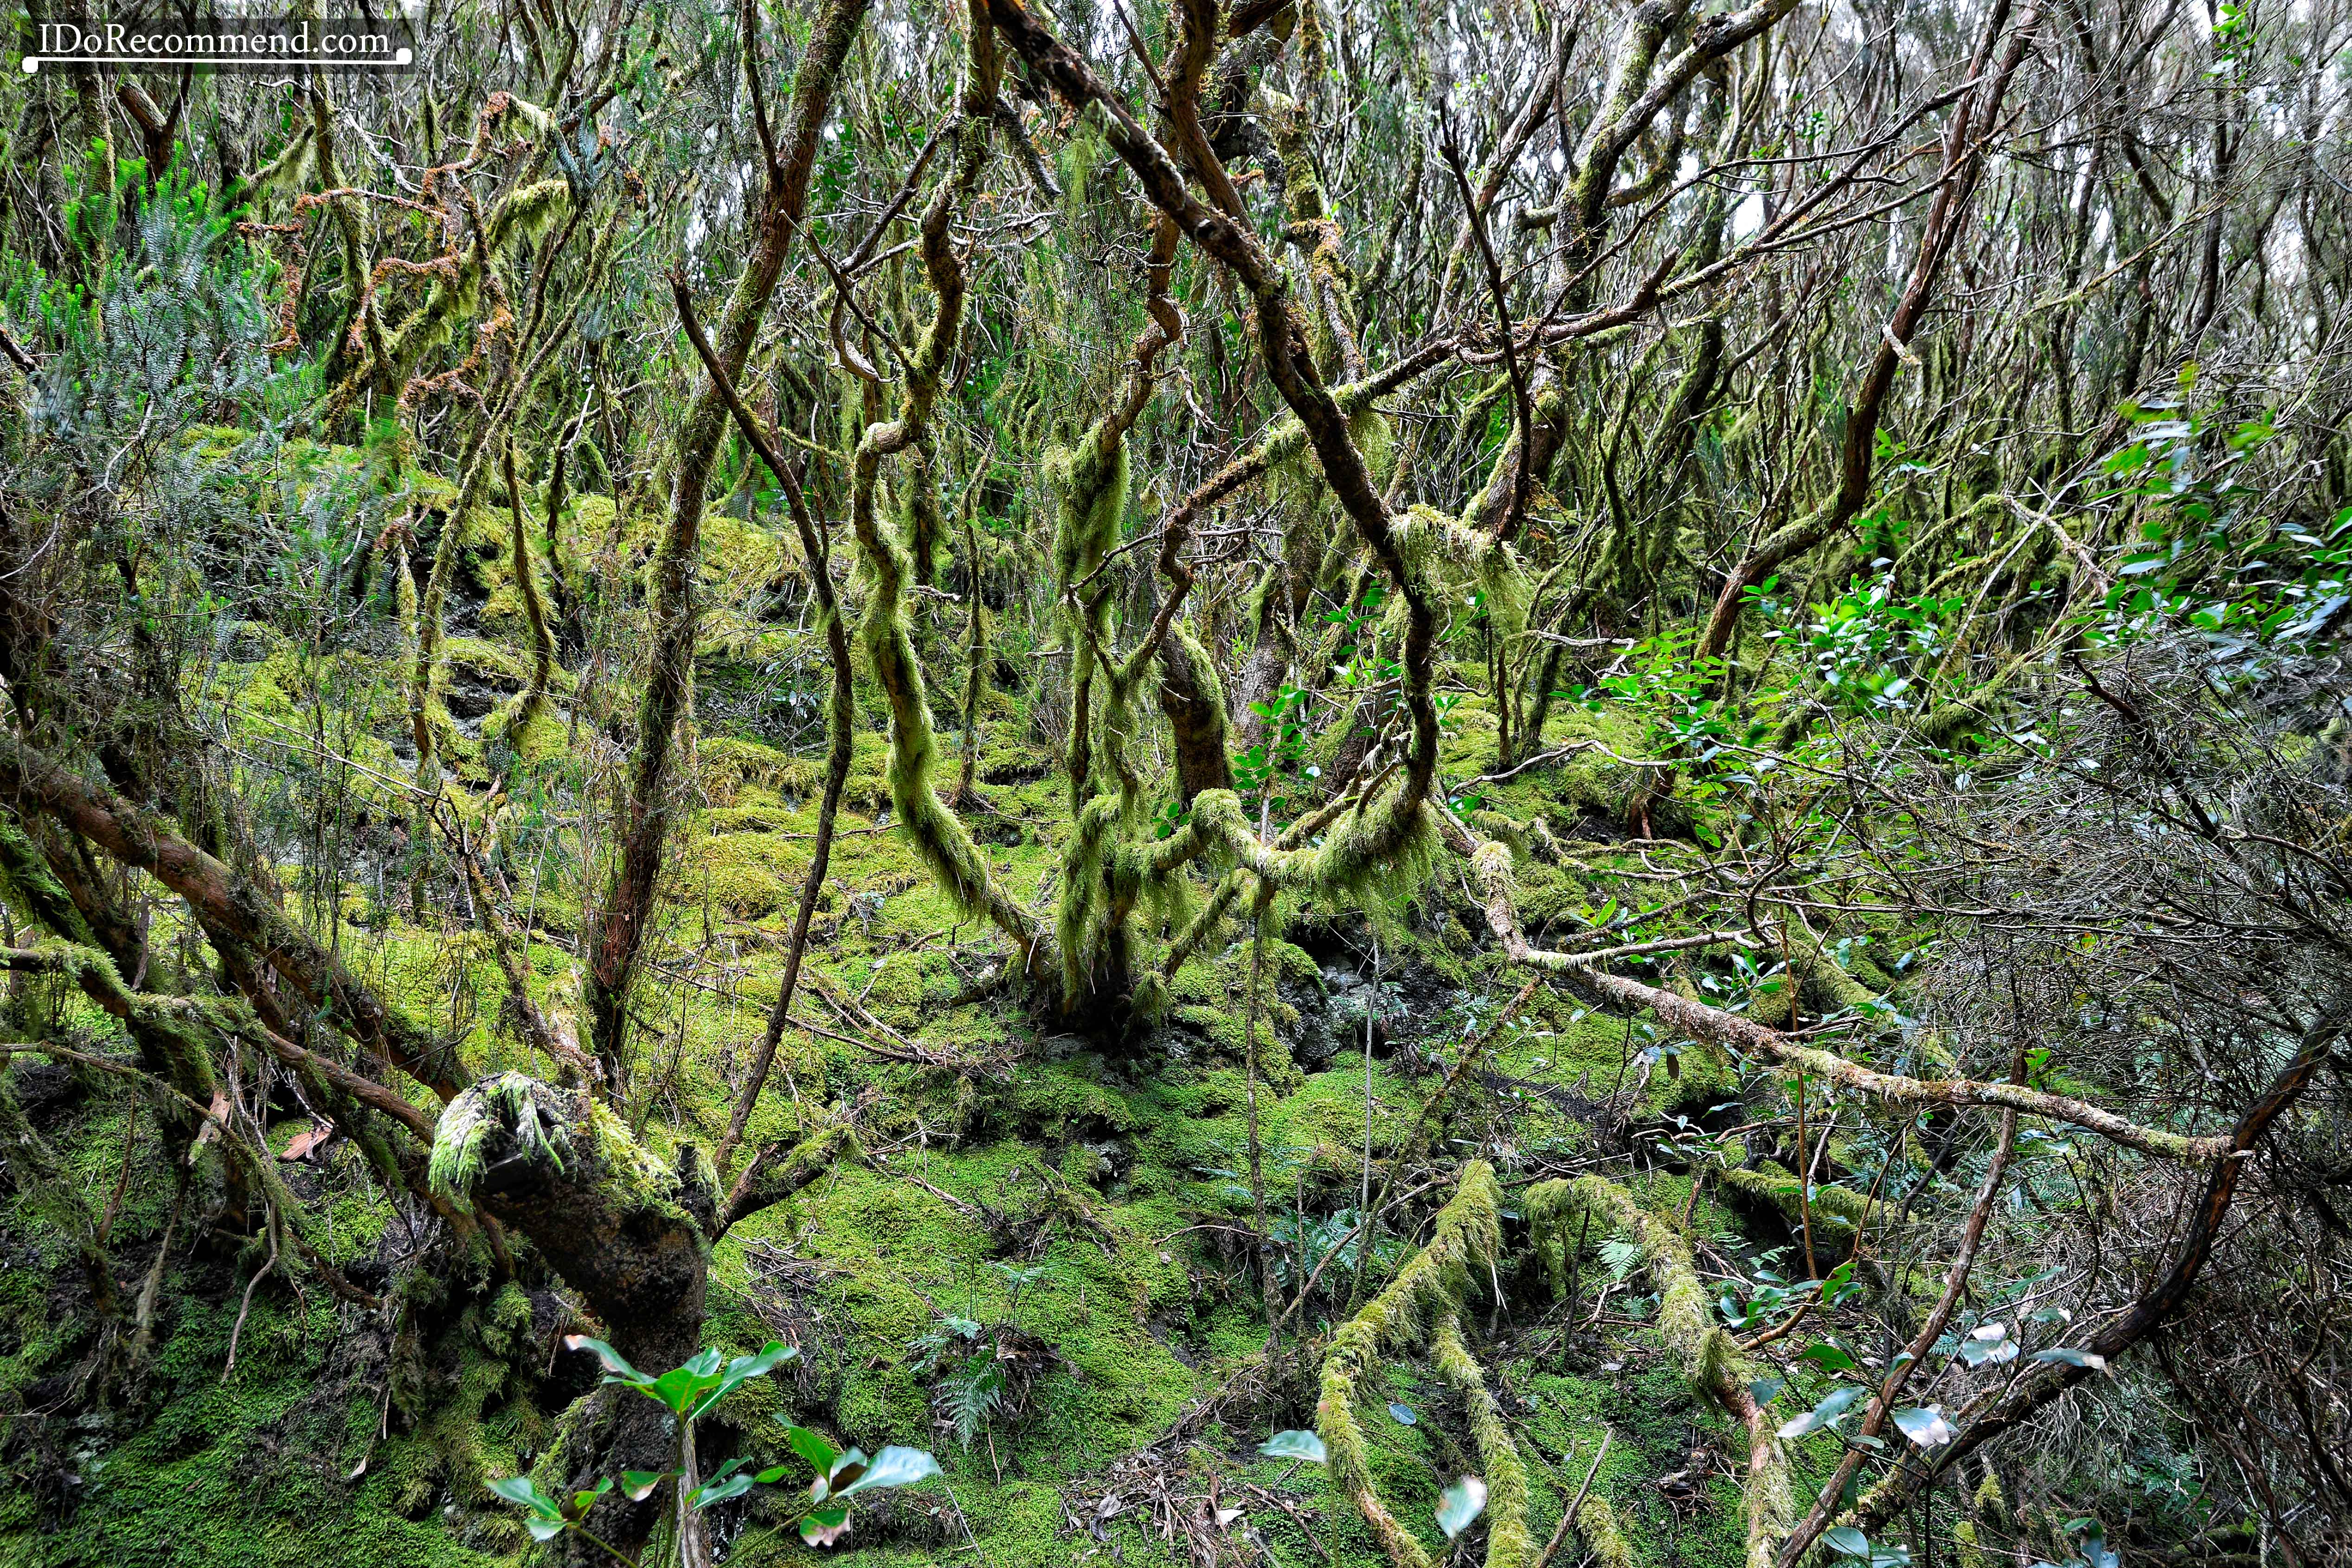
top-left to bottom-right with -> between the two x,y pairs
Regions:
0,494 -> 1872,1568
